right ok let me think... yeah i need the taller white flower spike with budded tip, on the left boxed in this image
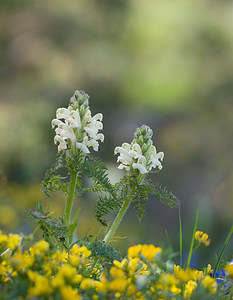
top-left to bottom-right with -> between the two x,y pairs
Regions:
52,91 -> 104,156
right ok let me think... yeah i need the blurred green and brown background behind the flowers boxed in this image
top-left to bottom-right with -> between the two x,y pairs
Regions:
0,0 -> 233,264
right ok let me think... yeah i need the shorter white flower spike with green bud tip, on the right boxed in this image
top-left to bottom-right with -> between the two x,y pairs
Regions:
114,125 -> 164,182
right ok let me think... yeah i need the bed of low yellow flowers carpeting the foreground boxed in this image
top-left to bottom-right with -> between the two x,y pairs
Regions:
0,234 -> 226,300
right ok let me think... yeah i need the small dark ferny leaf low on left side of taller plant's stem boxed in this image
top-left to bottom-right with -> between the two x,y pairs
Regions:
27,209 -> 70,243
